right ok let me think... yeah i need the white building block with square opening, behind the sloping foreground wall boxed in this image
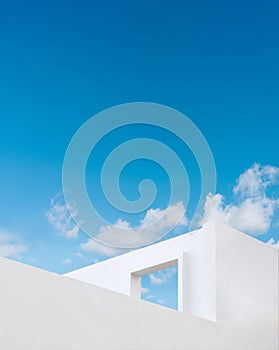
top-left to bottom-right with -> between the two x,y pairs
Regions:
68,222 -> 279,349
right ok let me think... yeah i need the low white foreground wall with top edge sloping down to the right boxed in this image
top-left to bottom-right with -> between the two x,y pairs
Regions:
0,254 -> 226,350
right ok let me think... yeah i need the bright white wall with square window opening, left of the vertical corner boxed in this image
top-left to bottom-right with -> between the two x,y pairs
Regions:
67,223 -> 216,321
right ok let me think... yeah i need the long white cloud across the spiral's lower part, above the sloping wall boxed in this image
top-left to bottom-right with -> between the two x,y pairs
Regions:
81,202 -> 187,256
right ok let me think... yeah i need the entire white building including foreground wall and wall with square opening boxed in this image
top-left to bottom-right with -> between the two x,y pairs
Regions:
0,222 -> 279,350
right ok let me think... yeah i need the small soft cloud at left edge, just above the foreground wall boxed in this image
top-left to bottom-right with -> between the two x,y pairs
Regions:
0,229 -> 27,258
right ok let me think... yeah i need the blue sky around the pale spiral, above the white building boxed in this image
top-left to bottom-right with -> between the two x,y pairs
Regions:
0,0 -> 279,310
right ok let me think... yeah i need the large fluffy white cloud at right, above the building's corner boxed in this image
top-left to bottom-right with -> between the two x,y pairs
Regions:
201,164 -> 279,235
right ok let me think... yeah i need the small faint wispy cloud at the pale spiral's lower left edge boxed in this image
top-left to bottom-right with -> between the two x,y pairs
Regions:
46,195 -> 79,238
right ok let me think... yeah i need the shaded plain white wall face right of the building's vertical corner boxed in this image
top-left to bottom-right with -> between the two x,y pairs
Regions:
216,223 -> 279,349
